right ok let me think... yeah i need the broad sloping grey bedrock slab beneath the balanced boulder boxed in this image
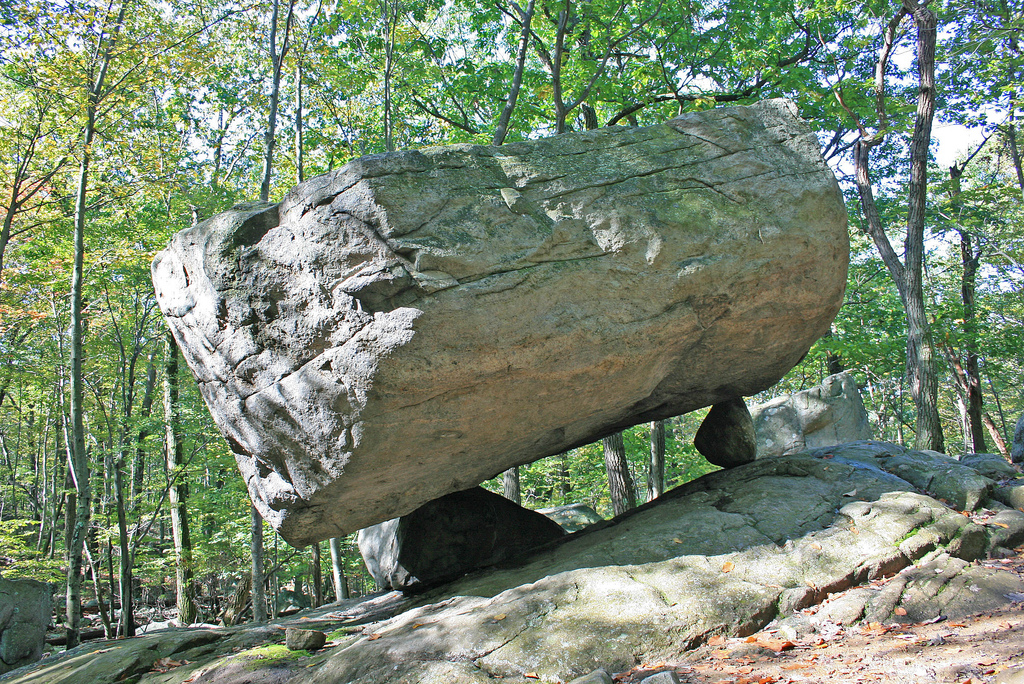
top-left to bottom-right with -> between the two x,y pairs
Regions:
4,441 -> 1024,684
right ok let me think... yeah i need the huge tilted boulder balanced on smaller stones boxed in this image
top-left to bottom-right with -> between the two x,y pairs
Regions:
153,100 -> 849,546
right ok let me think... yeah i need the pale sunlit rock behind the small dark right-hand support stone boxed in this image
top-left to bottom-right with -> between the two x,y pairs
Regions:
751,373 -> 871,458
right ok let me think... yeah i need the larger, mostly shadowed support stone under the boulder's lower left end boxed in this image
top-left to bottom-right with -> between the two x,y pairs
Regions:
358,487 -> 565,592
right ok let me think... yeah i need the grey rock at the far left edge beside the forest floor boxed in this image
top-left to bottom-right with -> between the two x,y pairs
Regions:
0,578 -> 50,674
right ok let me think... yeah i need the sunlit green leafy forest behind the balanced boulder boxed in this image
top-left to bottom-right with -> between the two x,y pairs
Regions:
0,0 -> 1024,646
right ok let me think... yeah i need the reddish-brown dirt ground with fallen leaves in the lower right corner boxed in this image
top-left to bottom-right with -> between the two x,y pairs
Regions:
614,549 -> 1024,684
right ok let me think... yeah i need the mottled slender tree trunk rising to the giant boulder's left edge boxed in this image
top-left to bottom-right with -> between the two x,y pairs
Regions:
164,331 -> 199,625
